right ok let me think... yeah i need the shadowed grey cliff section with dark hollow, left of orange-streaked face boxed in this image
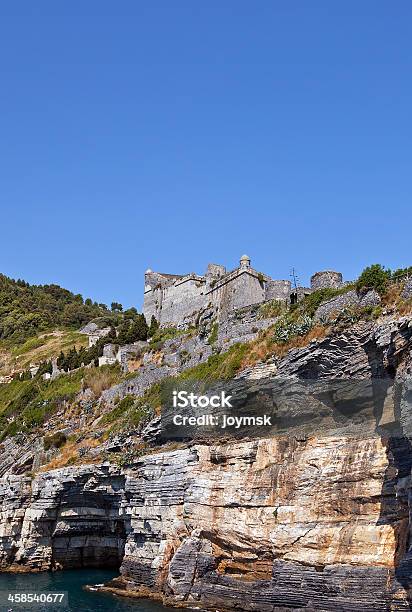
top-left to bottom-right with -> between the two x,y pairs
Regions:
0,466 -> 125,570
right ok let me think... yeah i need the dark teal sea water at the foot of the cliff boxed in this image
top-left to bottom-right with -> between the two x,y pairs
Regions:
0,569 -> 176,612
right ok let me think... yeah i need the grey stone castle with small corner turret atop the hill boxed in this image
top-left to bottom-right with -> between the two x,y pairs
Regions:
143,255 -> 343,327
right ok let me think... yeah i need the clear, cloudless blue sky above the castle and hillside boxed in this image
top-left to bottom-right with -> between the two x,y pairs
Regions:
0,0 -> 412,306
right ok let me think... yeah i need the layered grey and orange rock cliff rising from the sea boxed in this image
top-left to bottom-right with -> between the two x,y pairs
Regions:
0,316 -> 412,612
